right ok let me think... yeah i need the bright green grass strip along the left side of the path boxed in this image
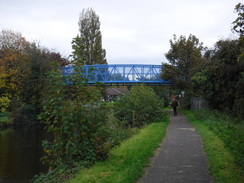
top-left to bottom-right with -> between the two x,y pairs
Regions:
67,117 -> 169,183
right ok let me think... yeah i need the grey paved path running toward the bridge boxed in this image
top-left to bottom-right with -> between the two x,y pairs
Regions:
138,112 -> 212,183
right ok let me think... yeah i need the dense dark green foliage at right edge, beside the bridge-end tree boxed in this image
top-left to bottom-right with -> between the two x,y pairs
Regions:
192,39 -> 244,119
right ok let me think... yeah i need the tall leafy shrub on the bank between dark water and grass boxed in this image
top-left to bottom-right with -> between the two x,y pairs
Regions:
38,62 -> 108,168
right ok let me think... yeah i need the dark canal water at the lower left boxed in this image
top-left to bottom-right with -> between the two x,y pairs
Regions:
0,125 -> 50,183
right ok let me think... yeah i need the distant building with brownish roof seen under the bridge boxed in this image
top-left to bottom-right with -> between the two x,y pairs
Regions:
106,88 -> 130,102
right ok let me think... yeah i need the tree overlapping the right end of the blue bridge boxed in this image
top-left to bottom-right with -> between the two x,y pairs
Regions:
162,35 -> 204,96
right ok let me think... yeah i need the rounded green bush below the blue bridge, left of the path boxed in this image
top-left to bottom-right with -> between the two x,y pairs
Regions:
115,85 -> 164,127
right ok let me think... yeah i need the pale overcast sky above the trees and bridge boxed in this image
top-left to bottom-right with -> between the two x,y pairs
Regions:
0,0 -> 240,64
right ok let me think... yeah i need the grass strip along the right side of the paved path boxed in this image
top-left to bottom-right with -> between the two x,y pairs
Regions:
183,111 -> 244,183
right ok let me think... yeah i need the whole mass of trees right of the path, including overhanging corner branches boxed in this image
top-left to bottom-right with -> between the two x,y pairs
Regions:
162,3 -> 244,120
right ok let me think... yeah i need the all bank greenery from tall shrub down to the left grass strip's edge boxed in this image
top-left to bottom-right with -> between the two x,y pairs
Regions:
33,63 -> 128,182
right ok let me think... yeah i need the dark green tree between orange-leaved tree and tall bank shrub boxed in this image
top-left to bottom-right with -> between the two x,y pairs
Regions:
22,42 -> 68,114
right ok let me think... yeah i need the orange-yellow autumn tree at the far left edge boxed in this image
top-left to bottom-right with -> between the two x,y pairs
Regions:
0,30 -> 29,99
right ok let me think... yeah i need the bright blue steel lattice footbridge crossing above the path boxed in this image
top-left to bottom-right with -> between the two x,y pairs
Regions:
63,64 -> 171,85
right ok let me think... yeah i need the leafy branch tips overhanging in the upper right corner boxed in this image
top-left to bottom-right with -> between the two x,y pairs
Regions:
232,3 -> 244,36
